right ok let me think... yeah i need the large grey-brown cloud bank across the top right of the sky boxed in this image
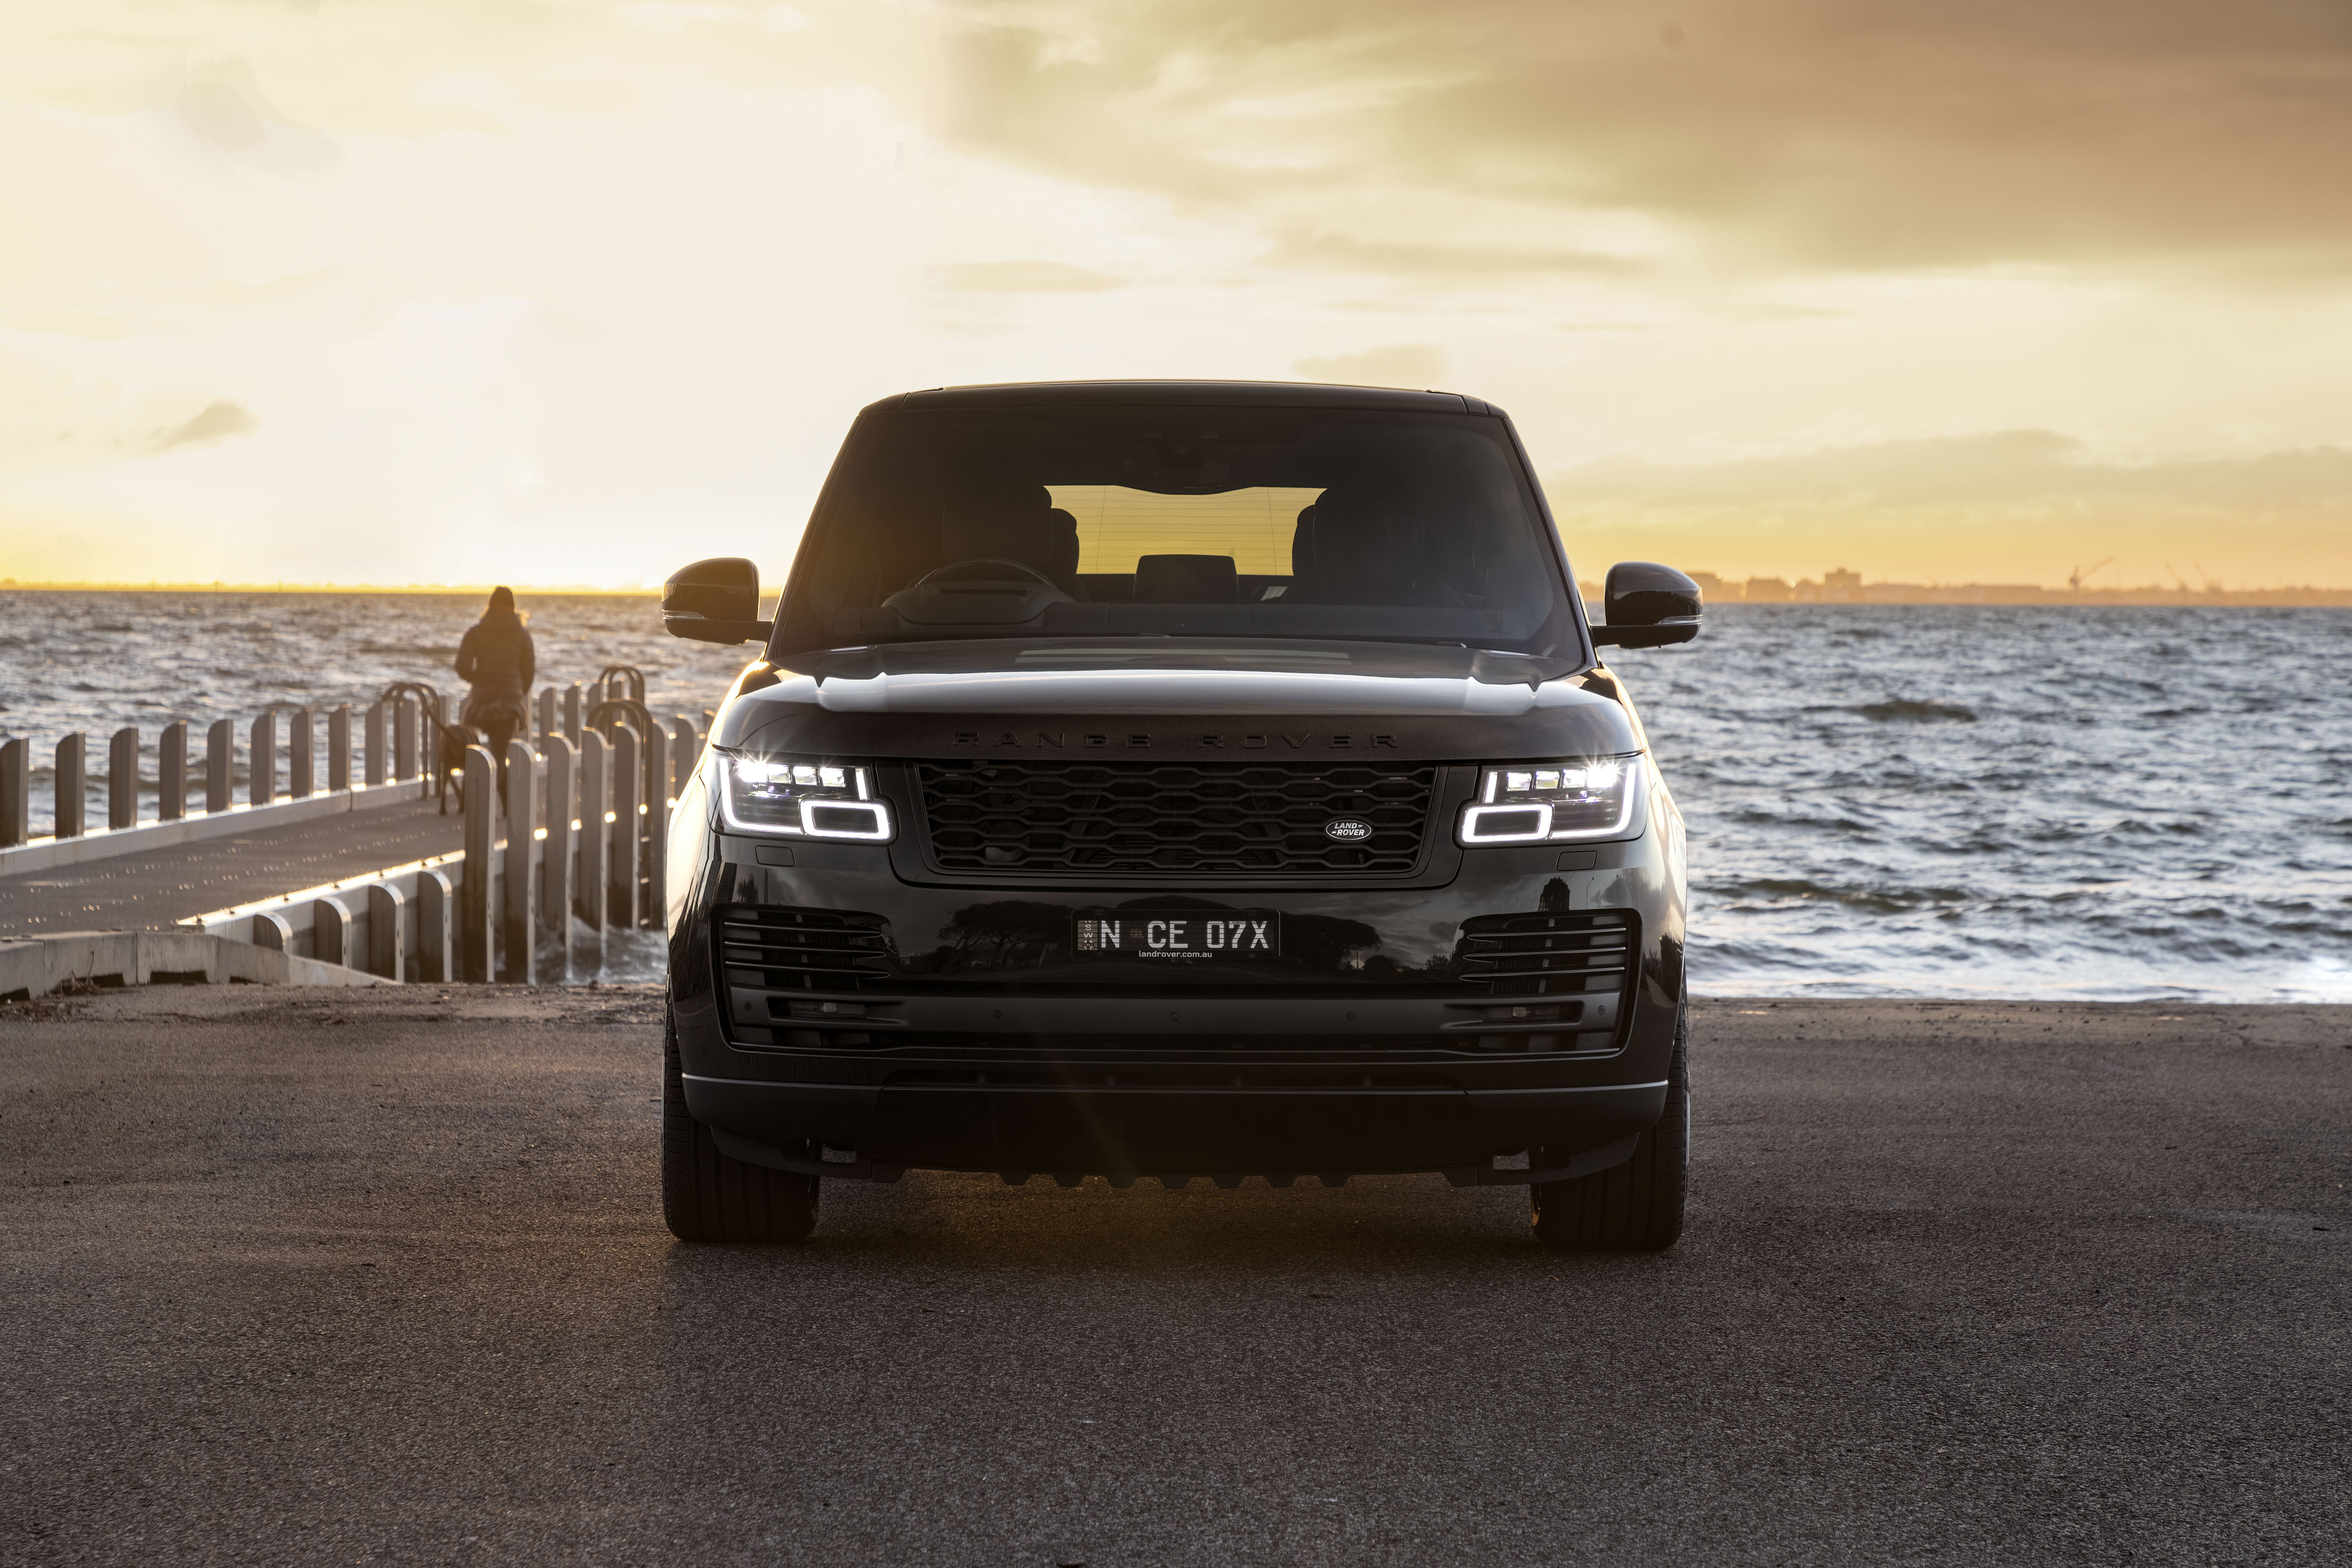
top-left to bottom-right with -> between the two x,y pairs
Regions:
927,0 -> 2352,273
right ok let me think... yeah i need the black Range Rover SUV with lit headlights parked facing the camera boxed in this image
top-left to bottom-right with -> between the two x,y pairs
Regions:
661,381 -> 1700,1248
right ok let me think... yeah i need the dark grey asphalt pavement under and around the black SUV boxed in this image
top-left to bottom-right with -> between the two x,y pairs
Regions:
0,987 -> 2352,1568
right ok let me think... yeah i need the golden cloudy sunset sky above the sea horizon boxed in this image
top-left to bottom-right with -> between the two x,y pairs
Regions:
0,0 -> 2352,588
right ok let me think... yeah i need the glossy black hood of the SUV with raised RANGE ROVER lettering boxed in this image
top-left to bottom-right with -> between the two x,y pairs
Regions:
717,639 -> 1639,762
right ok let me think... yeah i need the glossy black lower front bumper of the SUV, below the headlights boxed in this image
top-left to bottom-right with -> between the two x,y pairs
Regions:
670,835 -> 1682,1182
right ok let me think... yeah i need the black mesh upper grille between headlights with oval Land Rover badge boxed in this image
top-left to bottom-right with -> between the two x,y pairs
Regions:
915,759 -> 1437,877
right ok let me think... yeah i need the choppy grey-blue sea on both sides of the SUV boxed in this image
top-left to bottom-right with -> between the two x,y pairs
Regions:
0,588 -> 2352,1002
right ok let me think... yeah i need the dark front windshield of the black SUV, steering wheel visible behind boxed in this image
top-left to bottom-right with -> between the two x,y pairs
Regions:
776,406 -> 1578,653
